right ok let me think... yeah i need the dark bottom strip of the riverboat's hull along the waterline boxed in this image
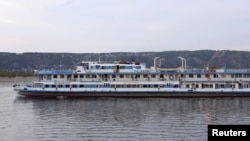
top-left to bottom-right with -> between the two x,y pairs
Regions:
18,91 -> 250,98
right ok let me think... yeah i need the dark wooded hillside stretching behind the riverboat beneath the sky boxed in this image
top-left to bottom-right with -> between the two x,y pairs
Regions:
0,50 -> 250,71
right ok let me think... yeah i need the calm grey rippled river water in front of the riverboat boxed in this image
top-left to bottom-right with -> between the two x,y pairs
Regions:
0,83 -> 250,141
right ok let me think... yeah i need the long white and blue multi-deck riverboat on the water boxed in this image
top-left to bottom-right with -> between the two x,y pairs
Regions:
14,57 -> 250,97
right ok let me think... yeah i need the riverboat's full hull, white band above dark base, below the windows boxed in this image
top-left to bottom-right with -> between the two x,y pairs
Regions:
14,83 -> 250,97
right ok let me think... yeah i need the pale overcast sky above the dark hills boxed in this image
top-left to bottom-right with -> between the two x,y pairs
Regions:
0,0 -> 250,53
